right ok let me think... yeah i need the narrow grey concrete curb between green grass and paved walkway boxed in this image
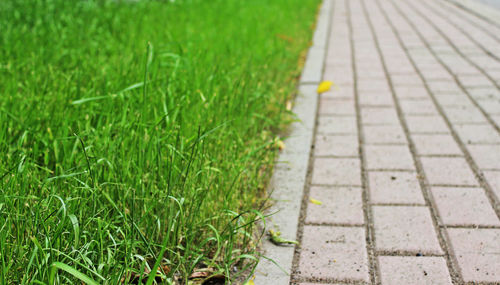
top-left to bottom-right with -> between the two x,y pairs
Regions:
255,0 -> 333,285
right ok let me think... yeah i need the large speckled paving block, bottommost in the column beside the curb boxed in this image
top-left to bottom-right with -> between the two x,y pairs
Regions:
298,225 -> 370,282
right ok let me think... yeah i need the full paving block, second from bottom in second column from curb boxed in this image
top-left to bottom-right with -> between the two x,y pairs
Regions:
372,206 -> 443,254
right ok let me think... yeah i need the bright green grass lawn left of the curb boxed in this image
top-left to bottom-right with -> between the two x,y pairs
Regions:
0,0 -> 319,284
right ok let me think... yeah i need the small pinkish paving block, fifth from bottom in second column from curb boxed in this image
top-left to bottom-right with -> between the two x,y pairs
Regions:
363,125 -> 407,144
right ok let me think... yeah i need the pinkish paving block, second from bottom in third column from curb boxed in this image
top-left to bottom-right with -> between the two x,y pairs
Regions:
431,187 -> 500,226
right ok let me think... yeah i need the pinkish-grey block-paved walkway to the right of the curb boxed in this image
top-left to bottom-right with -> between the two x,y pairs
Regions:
291,0 -> 500,285
